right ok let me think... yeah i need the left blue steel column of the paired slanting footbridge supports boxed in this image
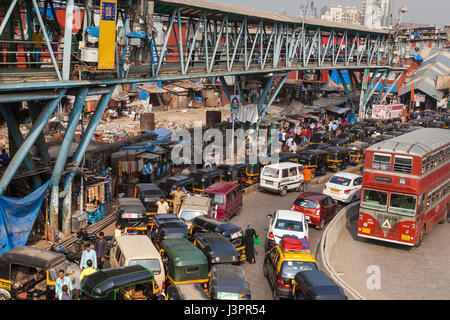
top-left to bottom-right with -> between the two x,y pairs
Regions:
48,87 -> 88,235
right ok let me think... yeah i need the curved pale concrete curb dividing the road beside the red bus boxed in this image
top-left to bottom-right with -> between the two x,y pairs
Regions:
318,202 -> 366,300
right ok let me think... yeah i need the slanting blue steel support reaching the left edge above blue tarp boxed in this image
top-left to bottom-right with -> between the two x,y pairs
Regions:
0,89 -> 67,195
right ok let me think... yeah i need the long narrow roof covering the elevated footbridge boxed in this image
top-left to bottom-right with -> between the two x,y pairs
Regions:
155,0 -> 390,34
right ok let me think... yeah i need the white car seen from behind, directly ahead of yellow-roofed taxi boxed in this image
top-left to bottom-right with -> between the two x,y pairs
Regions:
265,210 -> 309,251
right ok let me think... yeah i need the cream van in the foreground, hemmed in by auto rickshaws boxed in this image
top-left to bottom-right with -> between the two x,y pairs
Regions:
109,235 -> 166,291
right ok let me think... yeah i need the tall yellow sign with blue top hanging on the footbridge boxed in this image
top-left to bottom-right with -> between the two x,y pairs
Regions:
98,0 -> 117,69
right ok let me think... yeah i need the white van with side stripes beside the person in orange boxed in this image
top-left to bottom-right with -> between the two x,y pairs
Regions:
259,162 -> 304,197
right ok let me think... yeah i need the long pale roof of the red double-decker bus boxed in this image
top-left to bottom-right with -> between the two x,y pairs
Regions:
367,128 -> 450,157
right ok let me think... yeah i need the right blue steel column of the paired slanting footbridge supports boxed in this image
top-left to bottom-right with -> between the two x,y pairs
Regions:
62,85 -> 115,233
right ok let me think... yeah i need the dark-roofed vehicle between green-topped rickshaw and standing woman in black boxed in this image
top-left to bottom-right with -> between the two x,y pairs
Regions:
194,232 -> 241,266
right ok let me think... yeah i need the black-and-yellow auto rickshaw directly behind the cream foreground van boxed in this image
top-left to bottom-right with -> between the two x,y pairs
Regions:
116,198 -> 147,234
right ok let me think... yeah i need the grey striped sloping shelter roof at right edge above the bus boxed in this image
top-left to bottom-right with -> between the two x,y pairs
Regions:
399,49 -> 450,100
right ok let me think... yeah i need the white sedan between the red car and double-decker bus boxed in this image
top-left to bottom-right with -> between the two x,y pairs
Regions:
322,172 -> 362,203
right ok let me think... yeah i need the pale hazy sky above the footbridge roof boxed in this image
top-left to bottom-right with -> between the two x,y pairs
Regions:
213,0 -> 450,26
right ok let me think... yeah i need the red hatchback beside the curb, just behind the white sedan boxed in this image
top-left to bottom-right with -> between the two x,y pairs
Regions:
291,192 -> 338,230
